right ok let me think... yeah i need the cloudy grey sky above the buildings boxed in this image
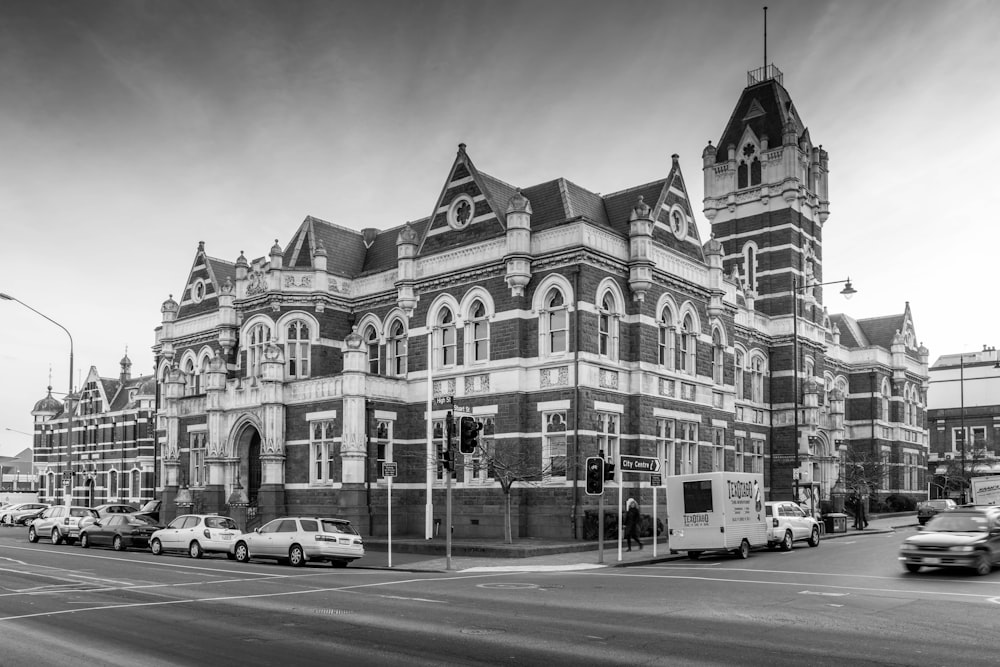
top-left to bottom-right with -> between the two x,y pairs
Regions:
0,0 -> 1000,455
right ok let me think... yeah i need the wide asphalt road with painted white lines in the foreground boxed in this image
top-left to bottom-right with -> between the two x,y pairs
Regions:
0,529 -> 1000,666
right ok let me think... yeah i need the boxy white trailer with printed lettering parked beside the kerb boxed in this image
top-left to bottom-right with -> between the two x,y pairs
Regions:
666,472 -> 767,559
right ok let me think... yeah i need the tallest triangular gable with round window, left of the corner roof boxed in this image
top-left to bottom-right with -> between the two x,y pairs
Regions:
417,144 -> 515,254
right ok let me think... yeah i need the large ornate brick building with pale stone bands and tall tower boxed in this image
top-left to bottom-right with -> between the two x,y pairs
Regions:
145,66 -> 927,538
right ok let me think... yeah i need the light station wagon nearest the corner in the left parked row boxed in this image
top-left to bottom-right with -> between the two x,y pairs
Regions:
236,517 -> 365,567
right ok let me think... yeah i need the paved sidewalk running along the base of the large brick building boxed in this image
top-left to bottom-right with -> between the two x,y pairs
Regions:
362,512 -> 917,572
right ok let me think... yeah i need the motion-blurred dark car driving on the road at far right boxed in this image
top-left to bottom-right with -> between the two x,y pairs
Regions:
899,506 -> 1000,575
